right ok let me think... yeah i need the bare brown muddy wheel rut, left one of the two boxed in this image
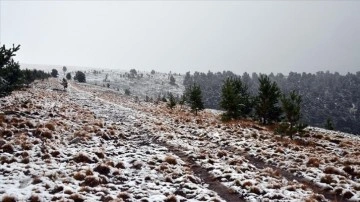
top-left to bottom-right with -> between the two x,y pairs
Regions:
153,140 -> 246,202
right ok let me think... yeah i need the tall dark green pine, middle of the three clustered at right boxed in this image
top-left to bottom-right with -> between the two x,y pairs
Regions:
255,74 -> 281,124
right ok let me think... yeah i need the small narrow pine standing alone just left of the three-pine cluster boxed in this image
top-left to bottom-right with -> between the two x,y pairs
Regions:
186,83 -> 204,115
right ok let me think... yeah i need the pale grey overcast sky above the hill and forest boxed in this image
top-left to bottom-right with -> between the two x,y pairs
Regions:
0,0 -> 360,74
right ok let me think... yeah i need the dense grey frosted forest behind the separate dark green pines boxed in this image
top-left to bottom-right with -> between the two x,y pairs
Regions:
184,71 -> 360,134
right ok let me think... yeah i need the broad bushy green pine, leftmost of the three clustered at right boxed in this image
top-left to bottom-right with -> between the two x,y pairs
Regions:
220,77 -> 252,120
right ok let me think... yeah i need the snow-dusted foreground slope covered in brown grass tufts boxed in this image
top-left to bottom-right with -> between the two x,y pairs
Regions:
0,80 -> 360,201
